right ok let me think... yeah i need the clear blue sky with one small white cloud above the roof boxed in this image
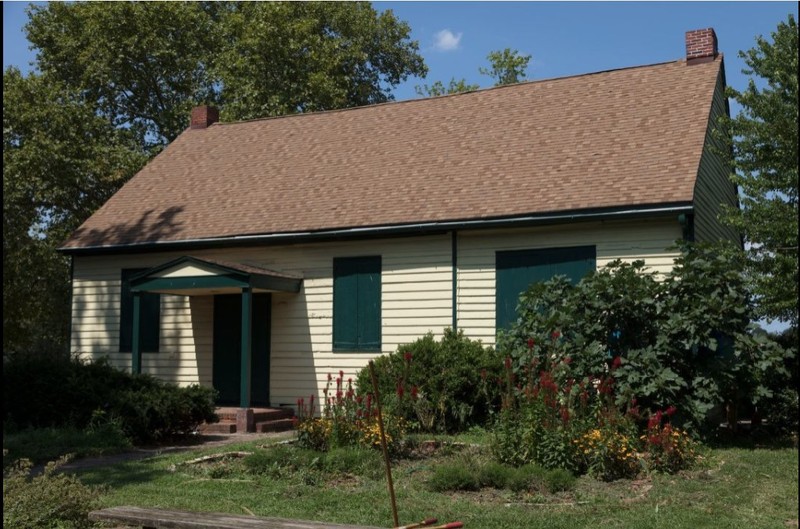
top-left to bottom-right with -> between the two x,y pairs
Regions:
3,2 -> 798,102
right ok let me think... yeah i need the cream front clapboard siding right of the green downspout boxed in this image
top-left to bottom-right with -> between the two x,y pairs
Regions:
457,216 -> 681,345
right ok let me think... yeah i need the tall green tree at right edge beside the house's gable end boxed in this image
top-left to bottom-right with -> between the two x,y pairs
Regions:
726,15 -> 798,327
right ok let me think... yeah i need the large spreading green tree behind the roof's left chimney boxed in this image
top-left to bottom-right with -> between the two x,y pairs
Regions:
26,2 -> 426,150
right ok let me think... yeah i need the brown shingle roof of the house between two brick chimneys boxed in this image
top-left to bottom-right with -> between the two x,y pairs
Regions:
64,57 -> 721,249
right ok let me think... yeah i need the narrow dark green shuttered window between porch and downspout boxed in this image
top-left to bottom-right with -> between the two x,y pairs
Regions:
333,256 -> 381,351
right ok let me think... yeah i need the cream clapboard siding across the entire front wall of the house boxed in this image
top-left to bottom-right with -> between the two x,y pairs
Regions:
72,220 -> 680,405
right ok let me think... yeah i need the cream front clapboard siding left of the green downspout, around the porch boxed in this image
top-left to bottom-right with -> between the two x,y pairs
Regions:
72,235 -> 452,404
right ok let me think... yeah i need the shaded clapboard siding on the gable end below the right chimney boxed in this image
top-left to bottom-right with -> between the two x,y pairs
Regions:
694,66 -> 741,244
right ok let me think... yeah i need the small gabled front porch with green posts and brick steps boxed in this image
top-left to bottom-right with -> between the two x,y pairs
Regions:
129,256 -> 302,408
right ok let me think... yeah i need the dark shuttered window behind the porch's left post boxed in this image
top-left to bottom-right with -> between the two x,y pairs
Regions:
119,268 -> 161,353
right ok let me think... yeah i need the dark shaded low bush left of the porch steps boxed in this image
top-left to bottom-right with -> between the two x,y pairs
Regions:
3,355 -> 217,444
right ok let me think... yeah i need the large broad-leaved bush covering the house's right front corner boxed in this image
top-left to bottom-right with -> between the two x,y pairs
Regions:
497,243 -> 787,433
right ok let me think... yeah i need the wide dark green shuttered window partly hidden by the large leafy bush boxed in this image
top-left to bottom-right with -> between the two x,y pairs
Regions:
495,246 -> 596,331
